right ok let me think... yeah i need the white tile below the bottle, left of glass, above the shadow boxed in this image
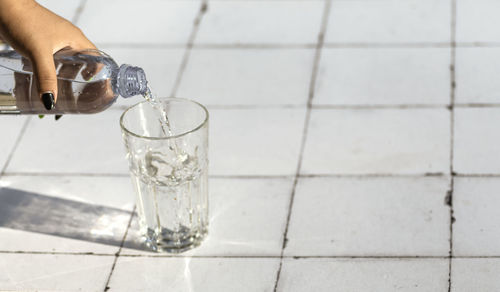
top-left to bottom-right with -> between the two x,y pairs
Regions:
7,110 -> 128,174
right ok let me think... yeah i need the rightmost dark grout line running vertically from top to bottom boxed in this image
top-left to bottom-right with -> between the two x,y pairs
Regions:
446,0 -> 457,292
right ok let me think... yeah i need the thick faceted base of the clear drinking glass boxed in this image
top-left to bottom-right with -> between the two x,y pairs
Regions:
143,226 -> 208,253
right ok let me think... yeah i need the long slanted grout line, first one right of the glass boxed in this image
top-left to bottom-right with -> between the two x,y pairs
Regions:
273,0 -> 331,292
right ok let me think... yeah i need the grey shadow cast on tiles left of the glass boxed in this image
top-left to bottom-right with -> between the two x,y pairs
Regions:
0,188 -> 147,250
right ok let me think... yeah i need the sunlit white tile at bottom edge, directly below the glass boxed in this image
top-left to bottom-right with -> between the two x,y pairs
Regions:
109,257 -> 279,292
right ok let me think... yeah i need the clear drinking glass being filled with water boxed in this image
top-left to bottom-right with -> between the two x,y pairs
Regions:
120,98 -> 208,252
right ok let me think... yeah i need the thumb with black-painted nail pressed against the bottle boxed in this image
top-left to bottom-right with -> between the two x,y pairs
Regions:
30,51 -> 57,110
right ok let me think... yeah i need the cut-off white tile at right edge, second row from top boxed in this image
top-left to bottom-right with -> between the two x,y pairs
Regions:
455,47 -> 500,103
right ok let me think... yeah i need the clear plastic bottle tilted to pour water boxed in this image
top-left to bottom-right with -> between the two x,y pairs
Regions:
0,49 -> 148,114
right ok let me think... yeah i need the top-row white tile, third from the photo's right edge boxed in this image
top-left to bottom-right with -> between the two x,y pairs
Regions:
196,1 -> 324,44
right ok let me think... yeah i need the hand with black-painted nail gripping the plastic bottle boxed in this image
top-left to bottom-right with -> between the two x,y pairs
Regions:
0,0 -> 96,110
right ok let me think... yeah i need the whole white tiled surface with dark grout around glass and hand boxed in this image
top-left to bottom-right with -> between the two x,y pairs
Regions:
0,0 -> 500,292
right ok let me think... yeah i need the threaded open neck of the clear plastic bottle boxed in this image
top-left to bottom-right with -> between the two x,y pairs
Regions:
115,64 -> 148,98
